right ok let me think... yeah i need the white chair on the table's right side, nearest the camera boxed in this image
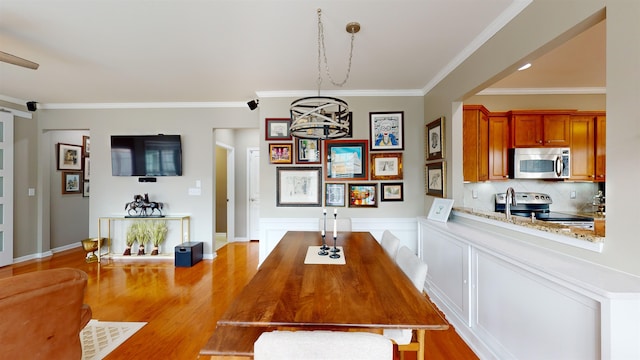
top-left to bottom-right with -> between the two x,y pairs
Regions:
383,246 -> 429,360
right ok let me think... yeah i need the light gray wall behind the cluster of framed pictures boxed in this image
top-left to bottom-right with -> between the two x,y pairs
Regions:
260,96 -> 426,218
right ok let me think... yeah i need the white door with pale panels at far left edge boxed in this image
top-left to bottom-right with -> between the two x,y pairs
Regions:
0,111 -> 13,266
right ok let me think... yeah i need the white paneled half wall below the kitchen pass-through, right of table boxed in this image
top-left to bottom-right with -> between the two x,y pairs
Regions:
418,216 -> 640,360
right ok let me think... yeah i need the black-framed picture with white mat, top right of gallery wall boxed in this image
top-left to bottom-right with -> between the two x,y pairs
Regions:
369,111 -> 404,151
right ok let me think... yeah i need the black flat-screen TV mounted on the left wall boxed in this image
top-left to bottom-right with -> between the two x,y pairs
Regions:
111,135 -> 182,176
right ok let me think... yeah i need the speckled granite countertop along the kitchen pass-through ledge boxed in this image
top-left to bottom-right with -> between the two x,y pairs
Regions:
453,207 -> 604,243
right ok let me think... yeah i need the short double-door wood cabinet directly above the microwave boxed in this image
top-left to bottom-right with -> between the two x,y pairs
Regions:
509,110 -> 575,148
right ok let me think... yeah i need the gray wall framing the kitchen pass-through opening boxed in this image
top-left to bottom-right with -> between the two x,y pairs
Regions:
424,0 -> 640,275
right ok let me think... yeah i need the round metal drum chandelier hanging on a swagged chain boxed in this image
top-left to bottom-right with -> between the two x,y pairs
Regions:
289,9 -> 360,140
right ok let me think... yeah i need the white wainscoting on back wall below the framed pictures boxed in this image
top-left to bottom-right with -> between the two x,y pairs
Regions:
258,216 -> 418,266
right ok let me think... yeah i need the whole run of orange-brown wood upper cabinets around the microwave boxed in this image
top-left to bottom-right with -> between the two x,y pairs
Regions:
462,105 -> 606,182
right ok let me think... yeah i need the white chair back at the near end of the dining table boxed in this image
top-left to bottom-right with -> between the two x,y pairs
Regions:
253,330 -> 393,360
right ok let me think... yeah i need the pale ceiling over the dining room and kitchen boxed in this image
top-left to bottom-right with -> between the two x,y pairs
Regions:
0,0 -> 605,104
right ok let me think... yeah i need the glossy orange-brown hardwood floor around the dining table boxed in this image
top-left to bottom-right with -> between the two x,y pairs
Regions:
0,242 -> 477,360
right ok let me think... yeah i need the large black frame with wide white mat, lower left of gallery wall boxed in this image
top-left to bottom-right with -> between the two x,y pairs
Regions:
276,167 -> 322,207
